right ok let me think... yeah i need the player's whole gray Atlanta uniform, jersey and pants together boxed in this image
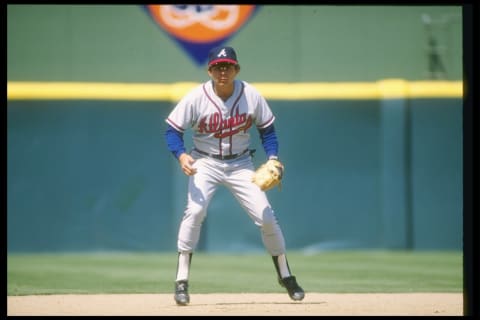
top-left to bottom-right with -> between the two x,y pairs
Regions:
166,80 -> 285,256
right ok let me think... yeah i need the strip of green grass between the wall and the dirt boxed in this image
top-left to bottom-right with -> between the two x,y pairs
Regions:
7,251 -> 463,295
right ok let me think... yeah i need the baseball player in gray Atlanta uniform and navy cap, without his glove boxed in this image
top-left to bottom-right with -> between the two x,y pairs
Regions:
165,47 -> 305,305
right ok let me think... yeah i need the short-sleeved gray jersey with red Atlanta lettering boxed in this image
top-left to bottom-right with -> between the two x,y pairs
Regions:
166,80 -> 275,155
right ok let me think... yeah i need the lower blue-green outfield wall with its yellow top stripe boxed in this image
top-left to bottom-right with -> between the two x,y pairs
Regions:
7,80 -> 463,252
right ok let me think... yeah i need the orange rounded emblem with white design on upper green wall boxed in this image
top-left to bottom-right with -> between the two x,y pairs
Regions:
148,5 -> 255,42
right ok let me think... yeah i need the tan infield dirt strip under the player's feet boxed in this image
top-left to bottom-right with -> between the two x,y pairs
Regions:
7,292 -> 463,316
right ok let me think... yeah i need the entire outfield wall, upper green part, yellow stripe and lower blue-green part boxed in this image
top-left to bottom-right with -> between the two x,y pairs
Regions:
7,4 -> 463,252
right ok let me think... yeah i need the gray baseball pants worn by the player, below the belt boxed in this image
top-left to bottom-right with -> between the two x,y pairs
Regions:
177,151 -> 285,256
